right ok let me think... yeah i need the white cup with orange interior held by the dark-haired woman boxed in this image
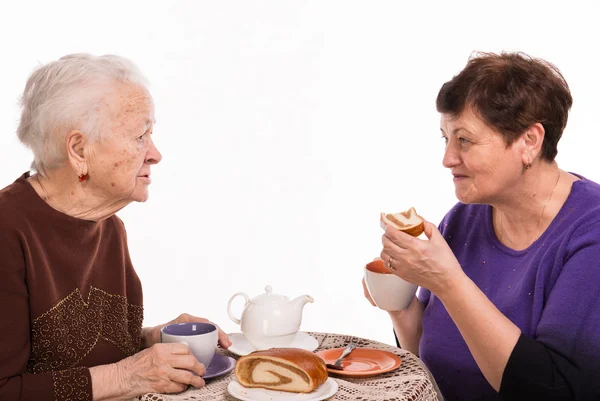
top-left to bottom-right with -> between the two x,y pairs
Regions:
365,259 -> 417,312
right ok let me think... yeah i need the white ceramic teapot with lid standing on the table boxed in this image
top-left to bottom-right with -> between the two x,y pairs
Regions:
227,285 -> 314,350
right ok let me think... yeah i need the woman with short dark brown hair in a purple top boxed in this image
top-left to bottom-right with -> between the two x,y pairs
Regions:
368,53 -> 600,401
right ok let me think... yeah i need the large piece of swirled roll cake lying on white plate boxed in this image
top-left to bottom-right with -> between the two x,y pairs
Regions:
235,348 -> 327,393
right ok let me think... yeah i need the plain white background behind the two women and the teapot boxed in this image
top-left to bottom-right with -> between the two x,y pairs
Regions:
0,0 -> 600,343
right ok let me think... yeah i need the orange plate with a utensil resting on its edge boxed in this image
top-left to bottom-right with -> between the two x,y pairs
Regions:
316,348 -> 401,377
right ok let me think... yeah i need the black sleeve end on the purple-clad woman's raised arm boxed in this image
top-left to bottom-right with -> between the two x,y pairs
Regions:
500,334 -> 584,401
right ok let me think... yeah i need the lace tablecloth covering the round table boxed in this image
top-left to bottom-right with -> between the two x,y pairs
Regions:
137,332 -> 443,401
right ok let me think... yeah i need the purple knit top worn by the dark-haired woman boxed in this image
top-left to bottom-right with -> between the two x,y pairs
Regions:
419,176 -> 600,401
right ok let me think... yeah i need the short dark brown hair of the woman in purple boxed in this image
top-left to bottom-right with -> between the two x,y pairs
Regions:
436,52 -> 573,161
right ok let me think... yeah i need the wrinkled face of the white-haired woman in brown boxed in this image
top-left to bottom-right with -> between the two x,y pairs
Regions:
88,85 -> 162,203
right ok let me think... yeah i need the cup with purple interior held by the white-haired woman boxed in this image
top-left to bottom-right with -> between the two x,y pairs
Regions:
160,322 -> 219,369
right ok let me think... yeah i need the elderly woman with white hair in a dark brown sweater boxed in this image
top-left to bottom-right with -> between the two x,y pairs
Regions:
0,54 -> 231,401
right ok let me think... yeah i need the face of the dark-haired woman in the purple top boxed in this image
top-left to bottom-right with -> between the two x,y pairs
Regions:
440,110 -> 523,204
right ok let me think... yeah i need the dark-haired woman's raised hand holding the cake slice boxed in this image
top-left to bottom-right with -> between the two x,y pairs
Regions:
381,221 -> 464,295
